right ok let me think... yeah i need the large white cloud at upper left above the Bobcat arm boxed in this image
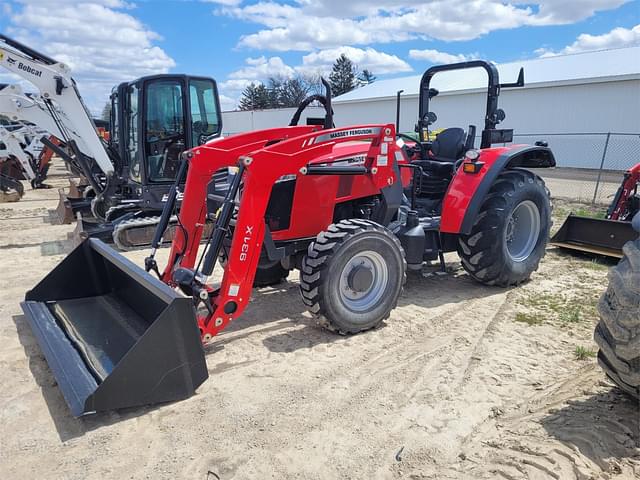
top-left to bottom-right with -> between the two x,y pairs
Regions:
1,0 -> 176,113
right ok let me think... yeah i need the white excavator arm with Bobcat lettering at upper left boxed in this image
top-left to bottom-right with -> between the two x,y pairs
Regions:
0,35 -> 114,176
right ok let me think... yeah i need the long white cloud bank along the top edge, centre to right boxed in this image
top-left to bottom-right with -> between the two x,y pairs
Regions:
215,0 -> 629,51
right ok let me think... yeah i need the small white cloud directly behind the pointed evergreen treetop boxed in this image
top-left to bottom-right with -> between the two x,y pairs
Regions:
296,46 -> 411,75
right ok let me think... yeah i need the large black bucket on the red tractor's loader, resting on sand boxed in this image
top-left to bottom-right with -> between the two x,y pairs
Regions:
21,238 -> 208,417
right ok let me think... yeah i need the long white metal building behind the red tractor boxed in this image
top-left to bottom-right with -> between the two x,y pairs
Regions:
223,47 -> 640,168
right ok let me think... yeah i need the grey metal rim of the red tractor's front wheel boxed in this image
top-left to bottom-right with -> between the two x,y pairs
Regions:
339,250 -> 389,313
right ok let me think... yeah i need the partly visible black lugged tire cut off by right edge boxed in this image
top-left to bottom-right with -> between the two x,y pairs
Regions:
594,240 -> 640,399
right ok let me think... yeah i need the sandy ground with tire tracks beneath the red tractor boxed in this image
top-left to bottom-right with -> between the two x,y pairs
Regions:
0,162 -> 640,480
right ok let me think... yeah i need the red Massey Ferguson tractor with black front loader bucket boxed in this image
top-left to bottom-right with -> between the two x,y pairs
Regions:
22,61 -> 555,415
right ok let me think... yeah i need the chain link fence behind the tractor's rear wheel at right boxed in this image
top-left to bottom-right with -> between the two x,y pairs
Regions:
496,132 -> 640,204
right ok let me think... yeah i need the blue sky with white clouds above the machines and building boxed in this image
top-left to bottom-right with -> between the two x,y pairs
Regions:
0,0 -> 640,112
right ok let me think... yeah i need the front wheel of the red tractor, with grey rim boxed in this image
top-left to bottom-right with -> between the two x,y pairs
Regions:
300,219 -> 407,335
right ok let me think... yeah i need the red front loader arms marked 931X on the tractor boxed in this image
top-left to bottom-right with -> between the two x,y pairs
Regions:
162,124 -> 400,342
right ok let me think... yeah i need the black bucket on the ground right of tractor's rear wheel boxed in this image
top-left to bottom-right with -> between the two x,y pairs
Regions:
550,214 -> 638,258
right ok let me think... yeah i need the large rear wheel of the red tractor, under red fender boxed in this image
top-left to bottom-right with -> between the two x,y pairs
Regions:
458,169 -> 551,287
